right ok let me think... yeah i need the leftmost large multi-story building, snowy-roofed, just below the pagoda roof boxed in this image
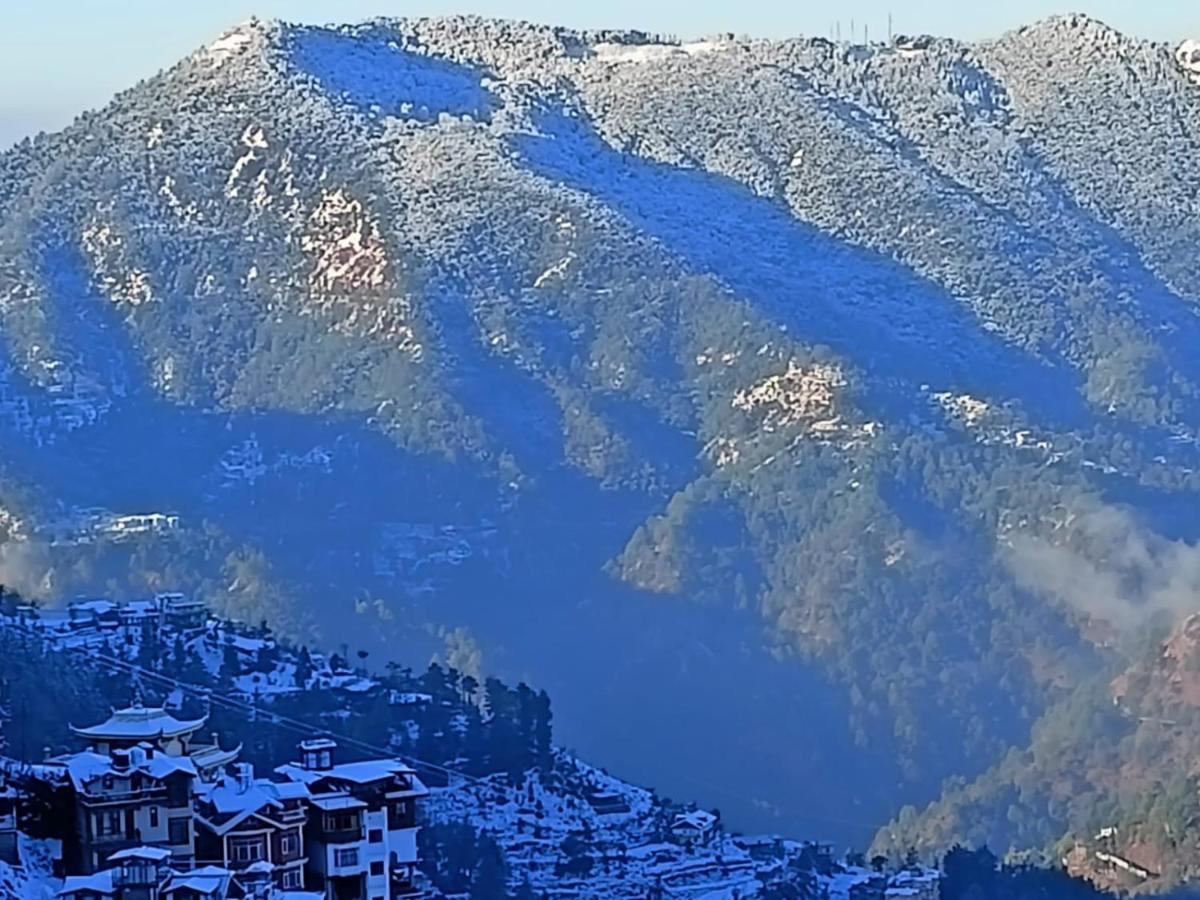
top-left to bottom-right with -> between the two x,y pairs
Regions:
58,744 -> 197,875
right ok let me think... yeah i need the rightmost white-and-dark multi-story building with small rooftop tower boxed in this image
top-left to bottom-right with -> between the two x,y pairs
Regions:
276,738 -> 428,900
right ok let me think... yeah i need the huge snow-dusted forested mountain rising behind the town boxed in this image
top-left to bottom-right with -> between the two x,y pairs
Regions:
0,7 -> 1200,864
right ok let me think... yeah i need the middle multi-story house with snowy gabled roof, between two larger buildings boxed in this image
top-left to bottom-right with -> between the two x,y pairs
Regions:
196,763 -> 308,890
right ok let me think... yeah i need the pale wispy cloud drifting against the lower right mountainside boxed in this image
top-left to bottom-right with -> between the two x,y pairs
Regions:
1006,505 -> 1200,629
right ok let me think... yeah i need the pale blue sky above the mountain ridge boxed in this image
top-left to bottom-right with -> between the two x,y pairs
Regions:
0,0 -> 1200,148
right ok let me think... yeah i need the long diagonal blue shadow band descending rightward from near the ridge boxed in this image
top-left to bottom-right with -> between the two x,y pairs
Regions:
514,101 -> 1086,424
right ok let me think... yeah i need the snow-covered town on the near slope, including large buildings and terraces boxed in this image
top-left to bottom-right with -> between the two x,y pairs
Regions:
0,593 -> 938,900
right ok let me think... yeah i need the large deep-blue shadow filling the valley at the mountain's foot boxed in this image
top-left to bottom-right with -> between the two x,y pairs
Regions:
0,229 -> 907,844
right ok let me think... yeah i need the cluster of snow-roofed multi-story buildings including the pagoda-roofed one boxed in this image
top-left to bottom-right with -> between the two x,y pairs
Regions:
0,702 -> 428,900
